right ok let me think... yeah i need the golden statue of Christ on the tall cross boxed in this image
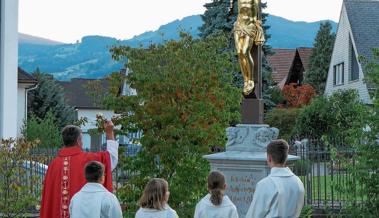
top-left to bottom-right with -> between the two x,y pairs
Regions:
230,0 -> 265,95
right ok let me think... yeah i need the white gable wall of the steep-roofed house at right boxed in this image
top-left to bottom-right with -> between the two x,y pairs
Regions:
325,5 -> 371,104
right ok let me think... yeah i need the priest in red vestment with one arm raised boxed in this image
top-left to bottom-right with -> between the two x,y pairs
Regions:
40,121 -> 118,218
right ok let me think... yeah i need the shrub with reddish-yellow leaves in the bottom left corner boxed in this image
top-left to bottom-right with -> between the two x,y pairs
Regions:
0,140 -> 41,218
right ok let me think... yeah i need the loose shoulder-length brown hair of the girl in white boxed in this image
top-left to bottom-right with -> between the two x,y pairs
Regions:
138,178 -> 168,210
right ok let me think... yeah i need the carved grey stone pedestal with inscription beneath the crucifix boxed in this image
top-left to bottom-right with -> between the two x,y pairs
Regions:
204,124 -> 299,218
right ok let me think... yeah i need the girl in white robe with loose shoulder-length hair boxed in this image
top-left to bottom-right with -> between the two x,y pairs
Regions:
135,178 -> 179,218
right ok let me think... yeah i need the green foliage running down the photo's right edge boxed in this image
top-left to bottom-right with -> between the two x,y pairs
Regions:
345,49 -> 379,217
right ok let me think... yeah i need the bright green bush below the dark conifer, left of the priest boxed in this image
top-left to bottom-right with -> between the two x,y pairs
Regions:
23,111 -> 62,148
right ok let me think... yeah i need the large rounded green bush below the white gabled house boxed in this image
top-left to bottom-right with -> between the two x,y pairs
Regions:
294,90 -> 367,139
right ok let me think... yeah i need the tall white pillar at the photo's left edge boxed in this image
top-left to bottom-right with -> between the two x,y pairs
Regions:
0,0 -> 18,138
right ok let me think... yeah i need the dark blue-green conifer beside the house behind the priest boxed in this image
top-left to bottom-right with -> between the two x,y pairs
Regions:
28,69 -> 75,127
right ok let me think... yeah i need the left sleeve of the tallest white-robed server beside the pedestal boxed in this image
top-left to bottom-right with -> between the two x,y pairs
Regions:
246,180 -> 277,218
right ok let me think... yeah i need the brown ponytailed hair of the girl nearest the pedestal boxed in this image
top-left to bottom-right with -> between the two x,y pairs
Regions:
208,171 -> 225,206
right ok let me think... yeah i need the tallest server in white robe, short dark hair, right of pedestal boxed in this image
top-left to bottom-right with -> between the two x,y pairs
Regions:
246,140 -> 304,218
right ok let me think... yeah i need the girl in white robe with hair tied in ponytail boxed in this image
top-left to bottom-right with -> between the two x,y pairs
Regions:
194,171 -> 238,218
